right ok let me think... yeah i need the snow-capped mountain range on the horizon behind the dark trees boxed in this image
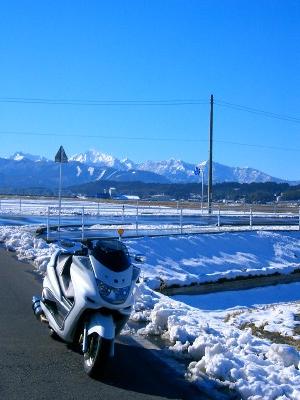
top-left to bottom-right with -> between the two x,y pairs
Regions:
4,150 -> 292,189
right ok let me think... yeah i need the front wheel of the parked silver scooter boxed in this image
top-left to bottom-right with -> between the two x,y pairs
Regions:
83,333 -> 113,378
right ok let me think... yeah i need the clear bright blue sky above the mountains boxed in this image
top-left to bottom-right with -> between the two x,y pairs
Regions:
0,0 -> 300,179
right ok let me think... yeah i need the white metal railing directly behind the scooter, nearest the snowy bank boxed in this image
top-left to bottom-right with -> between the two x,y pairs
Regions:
42,205 -> 300,240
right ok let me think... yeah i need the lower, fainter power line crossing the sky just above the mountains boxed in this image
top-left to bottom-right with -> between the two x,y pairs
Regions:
0,131 -> 300,152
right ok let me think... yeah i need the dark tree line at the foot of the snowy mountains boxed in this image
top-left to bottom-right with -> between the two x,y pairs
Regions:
0,181 -> 300,203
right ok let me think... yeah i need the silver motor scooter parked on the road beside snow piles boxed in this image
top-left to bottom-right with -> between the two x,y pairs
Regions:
32,240 -> 143,377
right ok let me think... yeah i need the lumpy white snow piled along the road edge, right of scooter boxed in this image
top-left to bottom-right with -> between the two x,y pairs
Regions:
132,283 -> 300,400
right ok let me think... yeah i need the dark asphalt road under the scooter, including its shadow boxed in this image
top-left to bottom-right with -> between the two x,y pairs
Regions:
0,249 -> 208,400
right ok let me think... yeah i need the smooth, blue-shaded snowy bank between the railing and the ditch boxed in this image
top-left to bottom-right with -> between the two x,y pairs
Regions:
126,232 -> 300,289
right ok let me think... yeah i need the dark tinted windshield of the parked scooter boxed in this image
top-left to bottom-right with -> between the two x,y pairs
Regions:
91,240 -> 131,272
